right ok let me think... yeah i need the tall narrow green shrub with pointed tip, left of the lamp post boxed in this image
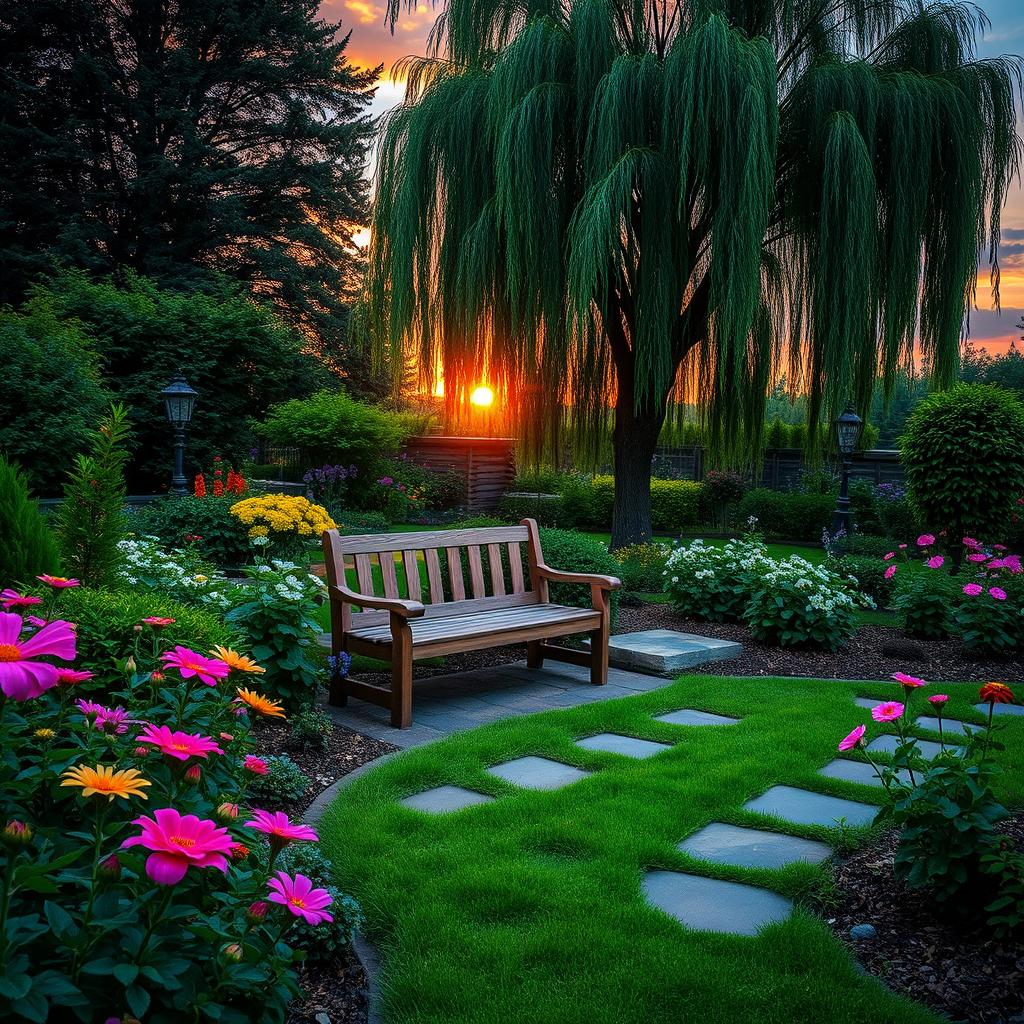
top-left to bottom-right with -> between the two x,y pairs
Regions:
54,406 -> 131,586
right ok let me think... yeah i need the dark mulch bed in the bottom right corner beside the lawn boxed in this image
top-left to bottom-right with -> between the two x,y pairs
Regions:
824,816 -> 1024,1024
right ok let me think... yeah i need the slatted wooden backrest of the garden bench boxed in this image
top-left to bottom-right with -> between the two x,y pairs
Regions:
324,519 -> 548,631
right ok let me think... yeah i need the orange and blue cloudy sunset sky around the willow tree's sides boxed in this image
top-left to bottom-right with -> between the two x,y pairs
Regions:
323,0 -> 1024,352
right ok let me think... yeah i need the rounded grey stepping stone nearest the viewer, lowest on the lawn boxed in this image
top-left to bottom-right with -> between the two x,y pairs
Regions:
643,871 -> 793,935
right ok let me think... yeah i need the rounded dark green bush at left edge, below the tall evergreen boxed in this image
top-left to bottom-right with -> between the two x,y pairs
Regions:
0,301 -> 106,491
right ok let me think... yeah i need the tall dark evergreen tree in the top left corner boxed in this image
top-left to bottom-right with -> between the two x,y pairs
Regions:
0,0 -> 379,372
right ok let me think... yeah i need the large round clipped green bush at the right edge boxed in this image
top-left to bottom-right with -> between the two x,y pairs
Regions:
900,384 -> 1024,552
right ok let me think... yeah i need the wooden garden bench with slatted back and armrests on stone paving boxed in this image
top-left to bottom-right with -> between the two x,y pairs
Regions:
324,519 -> 621,729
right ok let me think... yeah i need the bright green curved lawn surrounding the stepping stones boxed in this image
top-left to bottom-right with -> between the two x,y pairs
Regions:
319,676 -> 1024,1024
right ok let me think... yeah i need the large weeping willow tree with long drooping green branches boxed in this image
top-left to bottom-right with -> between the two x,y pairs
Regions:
368,0 -> 1021,546
